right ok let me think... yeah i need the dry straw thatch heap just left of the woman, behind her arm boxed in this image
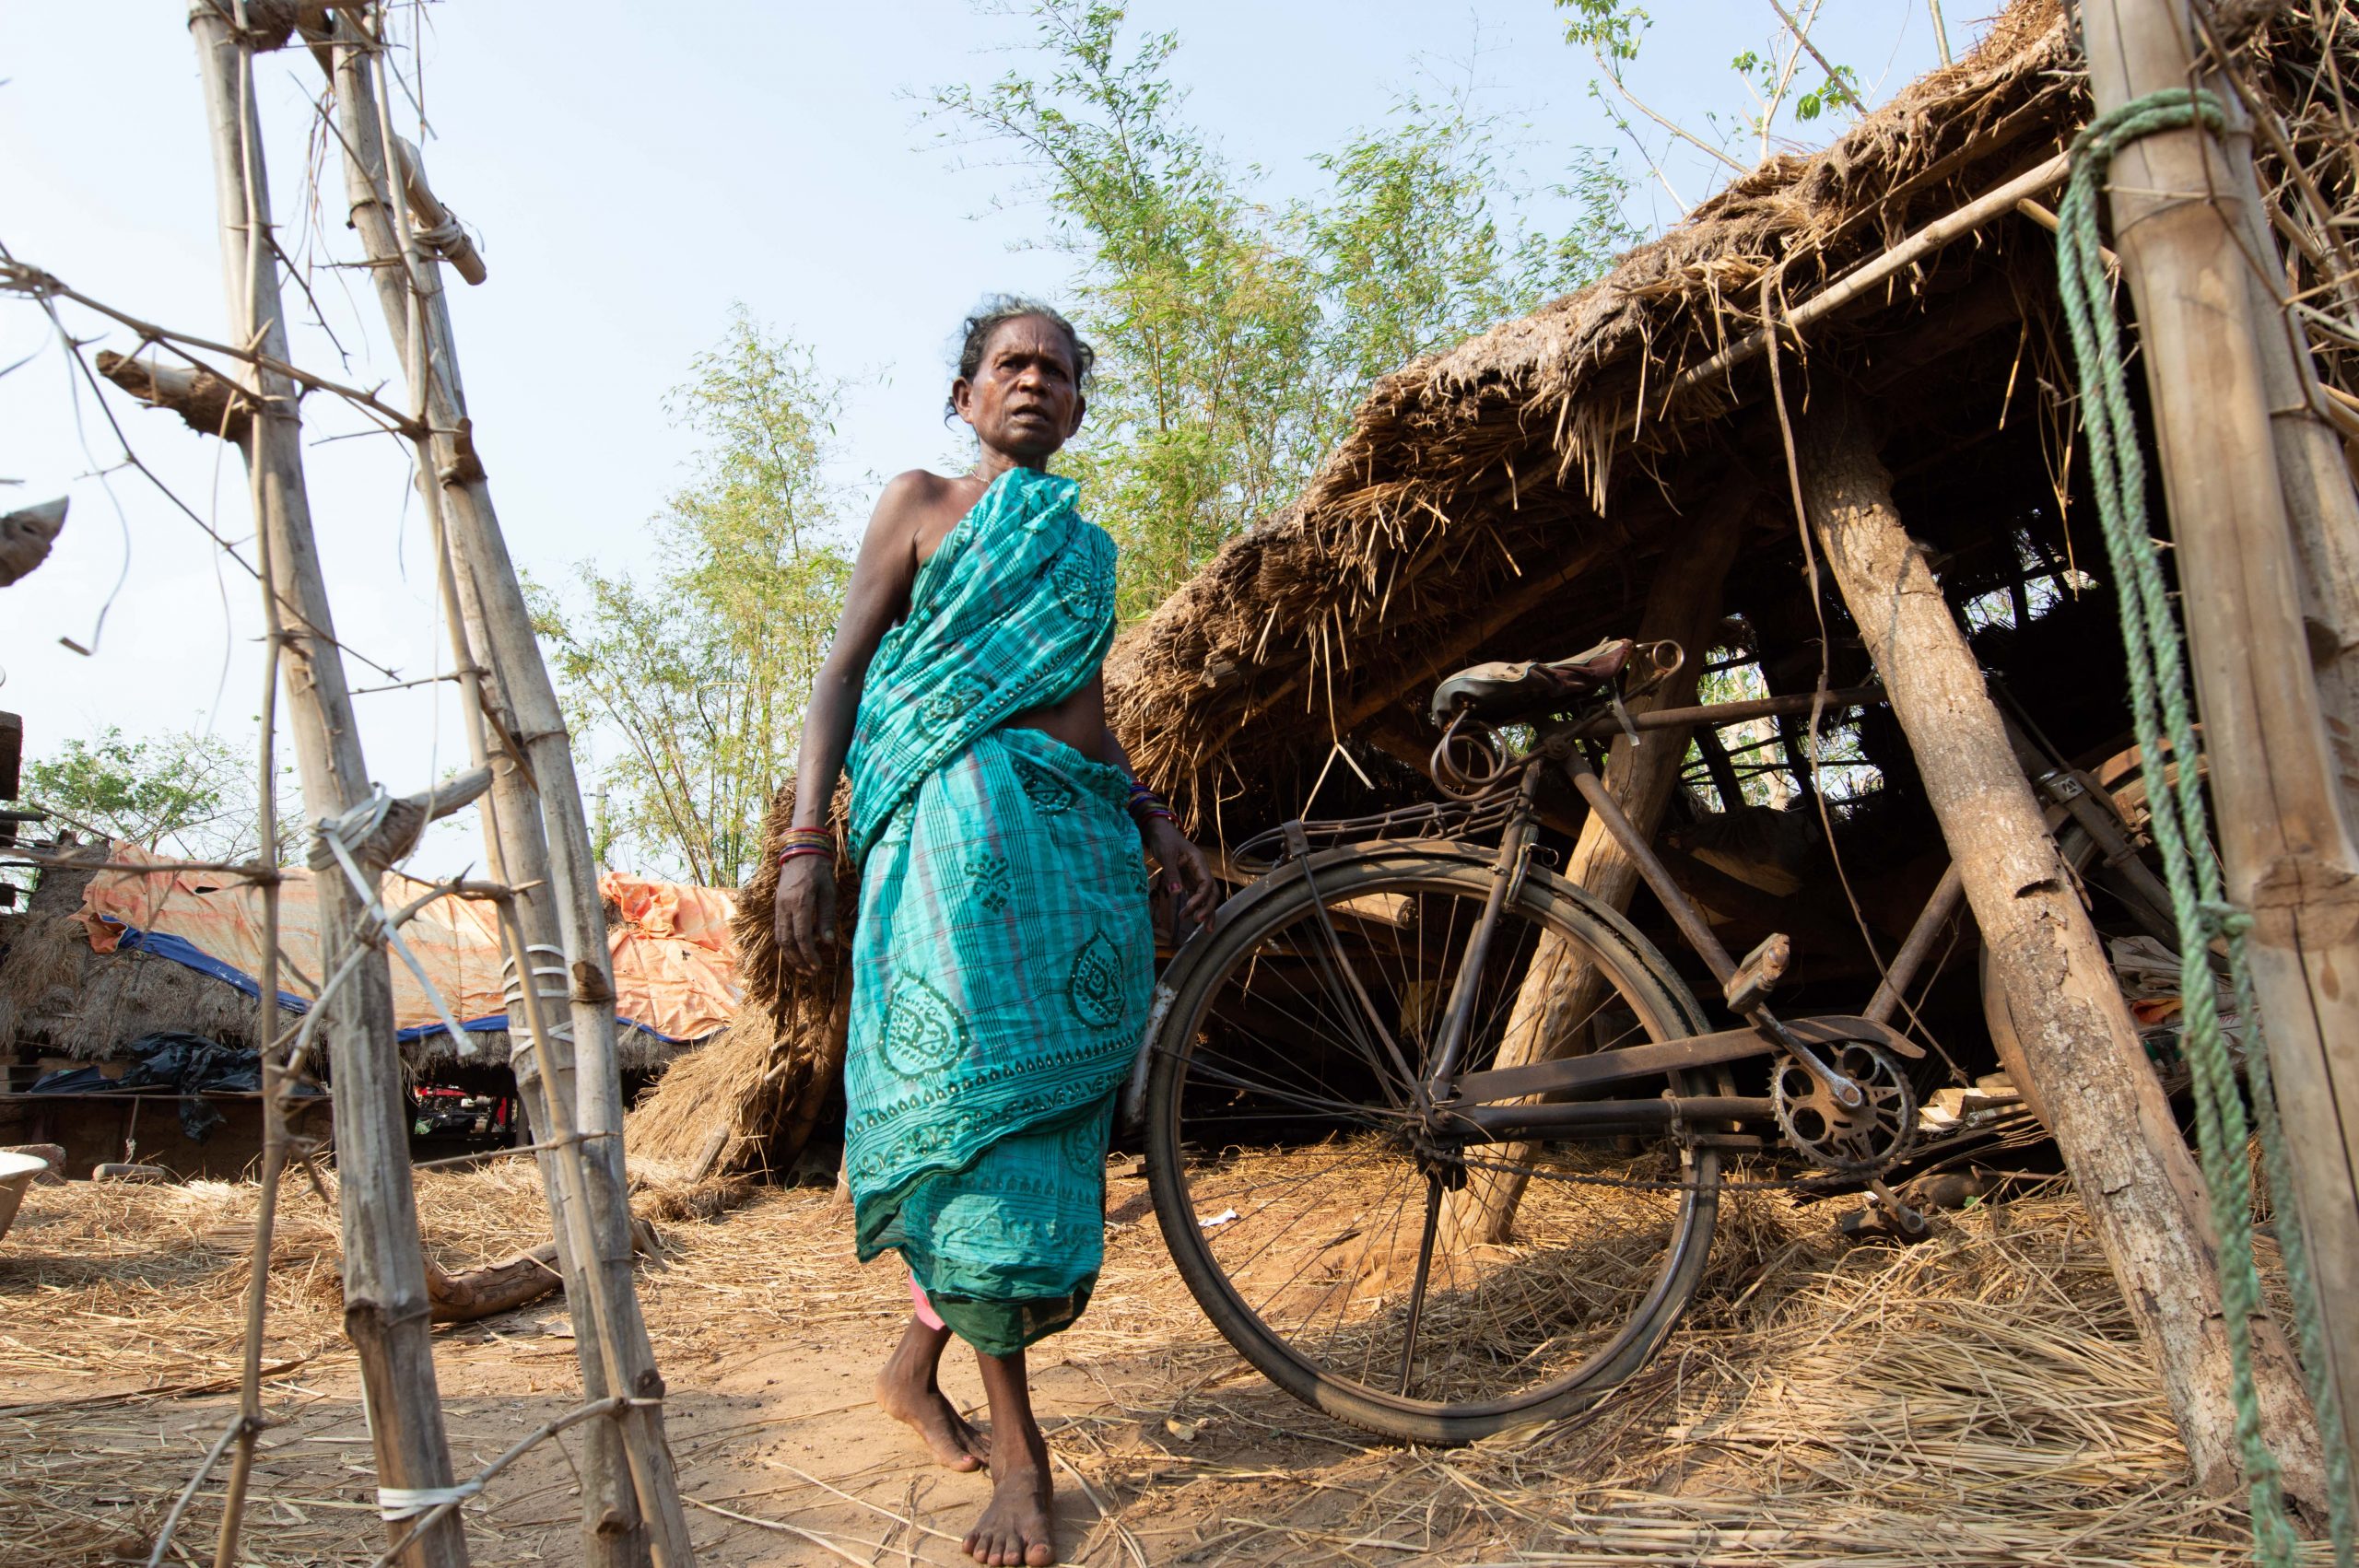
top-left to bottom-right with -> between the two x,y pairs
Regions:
623,780 -> 859,1181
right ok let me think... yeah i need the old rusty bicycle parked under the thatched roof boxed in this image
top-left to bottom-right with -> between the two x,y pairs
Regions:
1125,639 -> 2168,1443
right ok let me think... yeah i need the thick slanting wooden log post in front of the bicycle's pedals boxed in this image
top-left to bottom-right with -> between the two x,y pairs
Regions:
1800,387 -> 2326,1502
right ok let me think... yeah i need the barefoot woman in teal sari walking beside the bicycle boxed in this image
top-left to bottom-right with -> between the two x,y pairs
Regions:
776,302 -> 1215,1565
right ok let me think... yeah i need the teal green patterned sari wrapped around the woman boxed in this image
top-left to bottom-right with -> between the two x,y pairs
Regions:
844,469 -> 1154,1356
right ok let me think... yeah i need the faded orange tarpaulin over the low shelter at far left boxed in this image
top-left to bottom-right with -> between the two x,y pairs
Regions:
76,844 -> 738,1040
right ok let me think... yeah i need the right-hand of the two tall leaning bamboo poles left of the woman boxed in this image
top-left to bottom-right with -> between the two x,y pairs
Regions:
313,18 -> 691,1565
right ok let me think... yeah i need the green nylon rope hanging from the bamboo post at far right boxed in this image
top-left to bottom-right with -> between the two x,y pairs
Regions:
2057,89 -> 2352,1568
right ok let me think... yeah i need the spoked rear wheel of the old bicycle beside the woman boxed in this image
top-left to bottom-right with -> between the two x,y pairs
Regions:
1146,847 -> 1727,1443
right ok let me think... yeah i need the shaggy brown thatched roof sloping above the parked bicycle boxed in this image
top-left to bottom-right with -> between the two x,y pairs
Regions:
1109,0 -> 2088,816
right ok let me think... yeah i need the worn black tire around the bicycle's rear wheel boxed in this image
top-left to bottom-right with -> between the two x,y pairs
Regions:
1146,842 -> 1727,1443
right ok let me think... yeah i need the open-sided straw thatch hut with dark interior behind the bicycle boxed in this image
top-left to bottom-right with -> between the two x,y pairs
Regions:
658,0 -> 2359,1188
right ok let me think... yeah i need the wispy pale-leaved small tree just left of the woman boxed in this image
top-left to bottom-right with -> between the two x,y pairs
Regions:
531,307 -> 851,886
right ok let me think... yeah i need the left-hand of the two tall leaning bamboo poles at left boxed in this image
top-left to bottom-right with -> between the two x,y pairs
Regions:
189,0 -> 467,1568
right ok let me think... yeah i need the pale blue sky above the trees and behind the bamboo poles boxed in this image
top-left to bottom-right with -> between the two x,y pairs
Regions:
0,0 -> 1979,870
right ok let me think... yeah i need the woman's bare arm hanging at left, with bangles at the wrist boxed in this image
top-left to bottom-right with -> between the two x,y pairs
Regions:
771,469 -> 941,974
